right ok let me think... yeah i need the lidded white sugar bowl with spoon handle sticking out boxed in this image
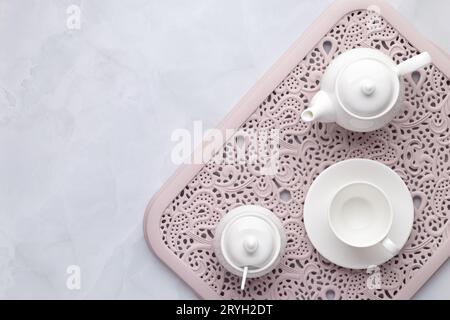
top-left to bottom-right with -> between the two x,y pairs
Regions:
214,205 -> 286,289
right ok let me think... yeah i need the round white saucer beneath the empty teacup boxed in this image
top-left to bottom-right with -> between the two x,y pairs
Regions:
304,159 -> 414,269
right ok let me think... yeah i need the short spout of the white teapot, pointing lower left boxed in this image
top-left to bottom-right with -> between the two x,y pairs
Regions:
301,91 -> 336,122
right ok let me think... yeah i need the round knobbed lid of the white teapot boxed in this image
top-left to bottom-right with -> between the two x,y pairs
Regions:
336,58 -> 400,118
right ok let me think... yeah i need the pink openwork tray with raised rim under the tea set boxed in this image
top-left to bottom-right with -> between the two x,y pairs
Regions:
144,0 -> 450,299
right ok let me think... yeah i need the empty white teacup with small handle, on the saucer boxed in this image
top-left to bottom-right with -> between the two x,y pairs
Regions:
328,181 -> 400,255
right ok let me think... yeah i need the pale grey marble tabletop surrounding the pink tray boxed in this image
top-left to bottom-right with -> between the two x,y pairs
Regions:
0,0 -> 450,299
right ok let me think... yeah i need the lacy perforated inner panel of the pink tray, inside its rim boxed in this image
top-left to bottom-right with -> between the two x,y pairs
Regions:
160,10 -> 450,299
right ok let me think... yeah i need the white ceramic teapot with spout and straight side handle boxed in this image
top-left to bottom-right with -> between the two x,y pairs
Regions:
301,48 -> 431,132
